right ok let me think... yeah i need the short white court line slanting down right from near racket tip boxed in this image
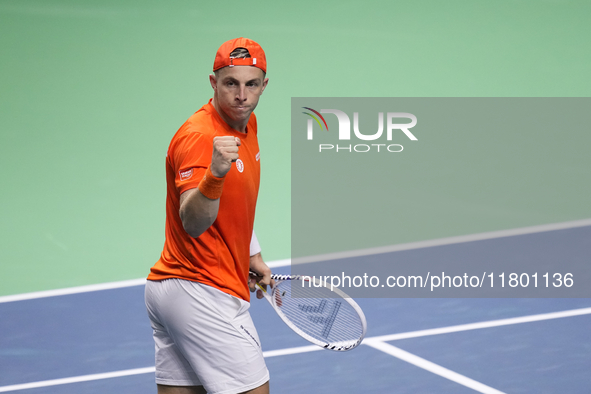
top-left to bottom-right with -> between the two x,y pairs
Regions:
363,339 -> 504,394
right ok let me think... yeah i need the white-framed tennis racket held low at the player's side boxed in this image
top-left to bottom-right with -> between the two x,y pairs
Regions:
250,272 -> 367,351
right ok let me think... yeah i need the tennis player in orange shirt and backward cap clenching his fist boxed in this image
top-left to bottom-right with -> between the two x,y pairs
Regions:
146,38 -> 271,394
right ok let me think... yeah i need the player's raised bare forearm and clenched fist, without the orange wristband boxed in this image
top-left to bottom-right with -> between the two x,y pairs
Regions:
179,136 -> 240,238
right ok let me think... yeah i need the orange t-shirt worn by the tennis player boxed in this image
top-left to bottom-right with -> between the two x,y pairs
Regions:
148,100 -> 260,301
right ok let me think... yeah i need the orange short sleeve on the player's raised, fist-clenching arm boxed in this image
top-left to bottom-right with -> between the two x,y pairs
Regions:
169,125 -> 213,194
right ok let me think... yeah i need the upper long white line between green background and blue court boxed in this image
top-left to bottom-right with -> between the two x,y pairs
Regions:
0,215 -> 591,303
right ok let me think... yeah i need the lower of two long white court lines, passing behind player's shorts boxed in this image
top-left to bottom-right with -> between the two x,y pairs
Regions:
0,308 -> 591,393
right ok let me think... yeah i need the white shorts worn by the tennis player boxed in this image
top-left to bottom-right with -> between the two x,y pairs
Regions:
145,279 -> 269,394
